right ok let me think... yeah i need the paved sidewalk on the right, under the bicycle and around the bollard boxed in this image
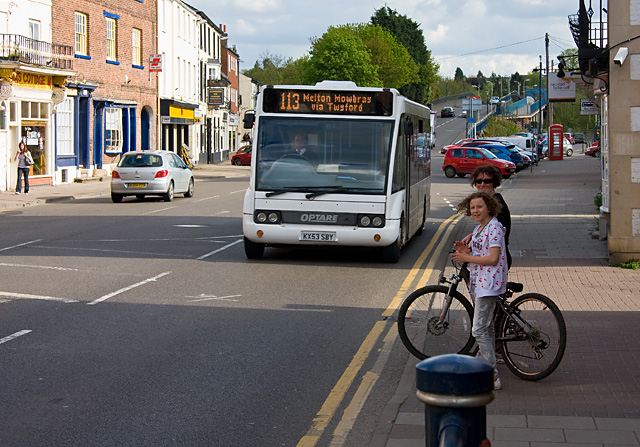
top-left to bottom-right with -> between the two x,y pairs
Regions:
370,154 -> 640,447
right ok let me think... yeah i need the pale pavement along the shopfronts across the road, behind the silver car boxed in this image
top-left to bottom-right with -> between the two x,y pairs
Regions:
0,161 -> 249,211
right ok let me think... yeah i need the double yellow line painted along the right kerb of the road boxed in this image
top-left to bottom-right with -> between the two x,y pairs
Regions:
297,214 -> 462,447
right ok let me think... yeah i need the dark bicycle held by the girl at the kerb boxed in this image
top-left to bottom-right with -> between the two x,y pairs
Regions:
398,263 -> 567,380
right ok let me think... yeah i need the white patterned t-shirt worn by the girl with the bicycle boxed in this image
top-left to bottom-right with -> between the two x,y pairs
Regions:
469,217 -> 508,298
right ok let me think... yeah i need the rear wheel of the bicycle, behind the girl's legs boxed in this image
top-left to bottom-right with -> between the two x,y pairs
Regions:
499,293 -> 567,380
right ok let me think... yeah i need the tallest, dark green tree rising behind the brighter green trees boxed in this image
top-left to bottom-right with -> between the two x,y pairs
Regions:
371,6 -> 439,103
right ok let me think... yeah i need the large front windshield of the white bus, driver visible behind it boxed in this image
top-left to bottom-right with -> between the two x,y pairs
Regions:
256,116 -> 394,196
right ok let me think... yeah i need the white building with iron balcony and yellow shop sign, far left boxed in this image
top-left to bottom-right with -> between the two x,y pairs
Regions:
0,0 -> 73,191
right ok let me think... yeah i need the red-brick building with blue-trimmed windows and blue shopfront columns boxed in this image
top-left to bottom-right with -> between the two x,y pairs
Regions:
51,0 -> 158,175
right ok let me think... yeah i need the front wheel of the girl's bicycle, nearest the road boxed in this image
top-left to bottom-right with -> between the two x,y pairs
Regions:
398,286 -> 474,360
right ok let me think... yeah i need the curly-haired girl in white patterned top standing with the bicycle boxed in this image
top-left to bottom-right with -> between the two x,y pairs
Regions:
451,192 -> 508,389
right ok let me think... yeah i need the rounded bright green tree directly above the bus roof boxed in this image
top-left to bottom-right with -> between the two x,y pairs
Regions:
304,26 -> 382,87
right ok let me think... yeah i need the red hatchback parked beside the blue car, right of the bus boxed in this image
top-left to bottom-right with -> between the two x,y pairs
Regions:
442,146 -> 516,178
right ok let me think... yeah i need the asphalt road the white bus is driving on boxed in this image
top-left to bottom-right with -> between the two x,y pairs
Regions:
0,115 -> 480,446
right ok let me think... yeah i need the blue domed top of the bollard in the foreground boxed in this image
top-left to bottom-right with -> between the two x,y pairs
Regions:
416,354 -> 493,396
